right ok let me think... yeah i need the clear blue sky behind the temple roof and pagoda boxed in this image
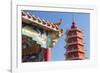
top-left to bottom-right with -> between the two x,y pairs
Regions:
25,10 -> 90,61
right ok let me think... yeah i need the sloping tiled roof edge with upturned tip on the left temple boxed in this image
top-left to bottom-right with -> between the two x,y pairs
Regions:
22,11 -> 61,31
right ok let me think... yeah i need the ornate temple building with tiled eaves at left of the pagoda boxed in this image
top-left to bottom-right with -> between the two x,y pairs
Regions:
21,11 -> 63,62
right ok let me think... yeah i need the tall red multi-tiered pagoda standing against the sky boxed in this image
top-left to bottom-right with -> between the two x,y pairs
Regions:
65,21 -> 86,60
